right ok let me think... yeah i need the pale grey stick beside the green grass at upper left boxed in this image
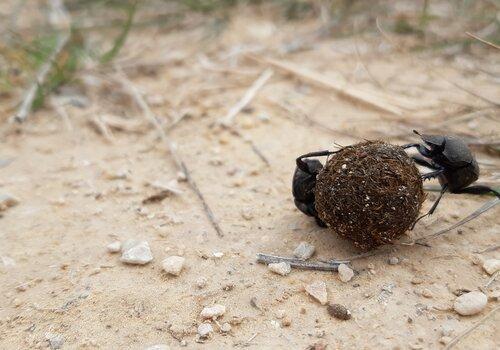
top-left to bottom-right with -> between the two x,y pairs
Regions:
11,33 -> 70,123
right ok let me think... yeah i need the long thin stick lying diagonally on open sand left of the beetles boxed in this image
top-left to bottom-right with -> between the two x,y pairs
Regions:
118,68 -> 224,237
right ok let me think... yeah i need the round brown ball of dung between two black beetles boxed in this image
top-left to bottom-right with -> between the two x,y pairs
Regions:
315,141 -> 425,250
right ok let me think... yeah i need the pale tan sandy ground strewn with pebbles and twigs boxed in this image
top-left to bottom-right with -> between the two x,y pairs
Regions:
0,3 -> 500,349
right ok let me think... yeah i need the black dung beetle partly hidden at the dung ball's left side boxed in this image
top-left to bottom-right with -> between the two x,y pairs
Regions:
292,151 -> 337,227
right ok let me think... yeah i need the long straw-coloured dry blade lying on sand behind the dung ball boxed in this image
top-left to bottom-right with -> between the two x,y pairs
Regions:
248,56 -> 403,116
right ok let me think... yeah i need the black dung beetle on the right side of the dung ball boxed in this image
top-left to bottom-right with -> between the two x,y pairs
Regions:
402,130 -> 500,226
